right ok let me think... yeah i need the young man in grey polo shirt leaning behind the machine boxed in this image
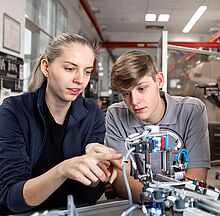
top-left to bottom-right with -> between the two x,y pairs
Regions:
106,50 -> 210,201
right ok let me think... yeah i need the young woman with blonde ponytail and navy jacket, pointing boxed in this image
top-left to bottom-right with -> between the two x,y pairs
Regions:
0,33 -> 121,215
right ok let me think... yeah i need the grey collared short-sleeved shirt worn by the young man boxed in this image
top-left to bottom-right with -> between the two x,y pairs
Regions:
105,91 -> 210,173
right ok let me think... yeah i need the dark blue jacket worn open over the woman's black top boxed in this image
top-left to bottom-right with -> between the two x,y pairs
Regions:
0,84 -> 105,215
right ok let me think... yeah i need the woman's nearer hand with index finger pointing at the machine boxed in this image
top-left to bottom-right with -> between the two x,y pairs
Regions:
60,152 -> 122,185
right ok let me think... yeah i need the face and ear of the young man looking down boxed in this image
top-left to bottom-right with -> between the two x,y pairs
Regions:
122,73 -> 163,124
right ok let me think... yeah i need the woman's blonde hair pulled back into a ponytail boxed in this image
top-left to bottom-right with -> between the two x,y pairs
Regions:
28,33 -> 99,92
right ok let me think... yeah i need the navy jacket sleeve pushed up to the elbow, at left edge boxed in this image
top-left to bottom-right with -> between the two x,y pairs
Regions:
0,100 -> 31,213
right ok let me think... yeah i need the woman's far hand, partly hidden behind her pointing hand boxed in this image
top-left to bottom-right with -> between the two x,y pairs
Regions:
86,143 -> 122,183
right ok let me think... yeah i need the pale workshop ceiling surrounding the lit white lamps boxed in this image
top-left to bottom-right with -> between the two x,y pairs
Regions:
88,0 -> 220,42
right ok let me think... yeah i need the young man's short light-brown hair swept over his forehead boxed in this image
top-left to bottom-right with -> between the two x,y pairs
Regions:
111,50 -> 158,92
